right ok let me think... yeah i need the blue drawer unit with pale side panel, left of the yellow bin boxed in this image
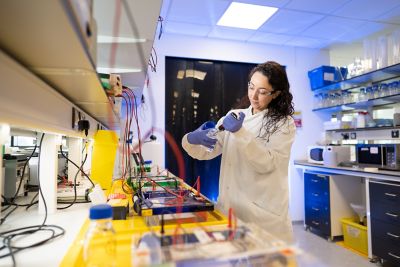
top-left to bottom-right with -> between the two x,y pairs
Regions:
304,172 -> 363,239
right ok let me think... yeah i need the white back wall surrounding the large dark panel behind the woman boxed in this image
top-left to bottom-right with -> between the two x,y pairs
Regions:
141,34 -> 329,220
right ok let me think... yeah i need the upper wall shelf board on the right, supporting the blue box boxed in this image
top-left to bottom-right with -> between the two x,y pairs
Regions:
313,63 -> 400,94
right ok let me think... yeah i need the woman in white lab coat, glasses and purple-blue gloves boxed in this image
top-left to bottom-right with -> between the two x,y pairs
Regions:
182,61 -> 296,245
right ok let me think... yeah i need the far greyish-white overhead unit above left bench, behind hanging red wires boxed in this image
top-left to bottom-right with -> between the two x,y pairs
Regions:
93,0 -> 162,92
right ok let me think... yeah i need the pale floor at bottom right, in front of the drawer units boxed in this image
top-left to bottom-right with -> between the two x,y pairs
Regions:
293,222 -> 394,267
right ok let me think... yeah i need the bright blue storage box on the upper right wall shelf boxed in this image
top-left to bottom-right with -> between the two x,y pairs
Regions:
308,66 -> 343,90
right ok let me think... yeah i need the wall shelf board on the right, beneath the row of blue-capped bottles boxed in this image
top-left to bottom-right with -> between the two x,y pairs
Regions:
313,94 -> 400,112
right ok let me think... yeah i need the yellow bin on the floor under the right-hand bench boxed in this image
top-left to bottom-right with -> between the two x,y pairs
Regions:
341,218 -> 368,255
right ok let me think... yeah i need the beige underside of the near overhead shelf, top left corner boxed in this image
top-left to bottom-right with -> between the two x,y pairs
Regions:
0,0 -> 119,128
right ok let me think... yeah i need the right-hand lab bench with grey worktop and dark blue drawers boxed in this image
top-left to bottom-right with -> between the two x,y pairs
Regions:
294,160 -> 400,264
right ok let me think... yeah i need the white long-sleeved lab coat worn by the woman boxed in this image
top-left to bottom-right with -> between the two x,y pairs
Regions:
182,107 -> 296,243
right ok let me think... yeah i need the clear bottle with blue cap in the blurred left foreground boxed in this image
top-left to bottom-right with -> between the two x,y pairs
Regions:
83,204 -> 117,267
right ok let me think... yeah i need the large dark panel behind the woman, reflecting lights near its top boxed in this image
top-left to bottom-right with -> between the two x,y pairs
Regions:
165,57 -> 257,203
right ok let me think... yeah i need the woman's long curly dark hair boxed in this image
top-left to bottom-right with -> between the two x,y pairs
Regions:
234,61 -> 294,141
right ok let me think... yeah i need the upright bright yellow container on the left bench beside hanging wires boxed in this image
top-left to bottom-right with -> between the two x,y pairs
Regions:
91,130 -> 118,189
